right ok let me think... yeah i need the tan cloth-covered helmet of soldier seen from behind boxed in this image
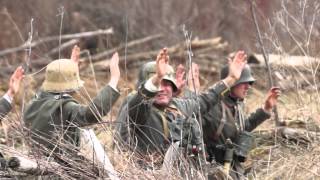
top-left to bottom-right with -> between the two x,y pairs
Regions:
42,59 -> 84,92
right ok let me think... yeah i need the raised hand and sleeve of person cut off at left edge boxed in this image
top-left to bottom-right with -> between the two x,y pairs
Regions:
0,66 -> 24,121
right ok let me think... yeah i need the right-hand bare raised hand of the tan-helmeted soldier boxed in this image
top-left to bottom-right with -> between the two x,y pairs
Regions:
109,52 -> 120,88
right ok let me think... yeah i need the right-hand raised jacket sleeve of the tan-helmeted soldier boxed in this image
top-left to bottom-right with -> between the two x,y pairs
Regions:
65,85 -> 120,126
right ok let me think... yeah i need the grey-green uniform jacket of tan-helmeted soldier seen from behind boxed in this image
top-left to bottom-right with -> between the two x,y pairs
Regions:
24,86 -> 119,152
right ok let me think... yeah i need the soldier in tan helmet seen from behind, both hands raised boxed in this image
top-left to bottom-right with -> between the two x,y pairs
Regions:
24,47 -> 120,160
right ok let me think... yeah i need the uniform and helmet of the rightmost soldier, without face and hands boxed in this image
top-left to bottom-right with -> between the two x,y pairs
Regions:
202,66 -> 271,179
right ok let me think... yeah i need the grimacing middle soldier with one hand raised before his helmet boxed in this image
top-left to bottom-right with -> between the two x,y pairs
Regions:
122,49 -> 202,170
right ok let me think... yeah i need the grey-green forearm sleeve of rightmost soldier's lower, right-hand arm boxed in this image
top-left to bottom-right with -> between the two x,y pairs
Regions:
245,108 -> 271,132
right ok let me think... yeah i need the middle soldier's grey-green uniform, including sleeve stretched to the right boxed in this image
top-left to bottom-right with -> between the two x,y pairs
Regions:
120,71 -> 240,152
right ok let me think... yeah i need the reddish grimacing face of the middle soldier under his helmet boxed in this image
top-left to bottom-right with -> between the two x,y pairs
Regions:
154,81 -> 173,106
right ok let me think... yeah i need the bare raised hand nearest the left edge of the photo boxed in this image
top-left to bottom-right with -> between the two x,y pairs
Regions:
7,66 -> 24,98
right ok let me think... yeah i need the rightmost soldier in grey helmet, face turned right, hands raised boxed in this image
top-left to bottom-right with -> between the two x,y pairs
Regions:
202,56 -> 280,179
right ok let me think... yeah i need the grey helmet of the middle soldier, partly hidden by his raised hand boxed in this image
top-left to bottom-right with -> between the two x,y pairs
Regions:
137,61 -> 178,91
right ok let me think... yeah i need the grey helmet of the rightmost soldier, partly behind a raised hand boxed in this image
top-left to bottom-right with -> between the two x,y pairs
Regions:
220,64 -> 256,86
